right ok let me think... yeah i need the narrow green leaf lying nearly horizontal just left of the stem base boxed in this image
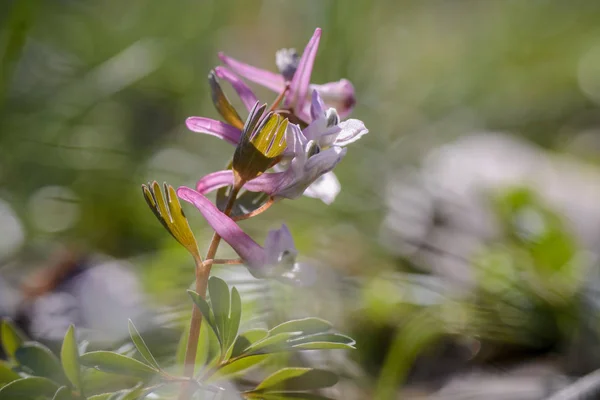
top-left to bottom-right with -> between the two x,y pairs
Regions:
80,351 -> 157,379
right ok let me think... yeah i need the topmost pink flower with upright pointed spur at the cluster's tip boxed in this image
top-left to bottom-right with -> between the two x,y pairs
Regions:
219,28 -> 356,123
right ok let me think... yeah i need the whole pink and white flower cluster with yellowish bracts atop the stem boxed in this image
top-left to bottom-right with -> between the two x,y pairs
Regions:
145,29 -> 368,284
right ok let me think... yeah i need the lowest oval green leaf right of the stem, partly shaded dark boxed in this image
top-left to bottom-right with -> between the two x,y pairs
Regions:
254,368 -> 338,392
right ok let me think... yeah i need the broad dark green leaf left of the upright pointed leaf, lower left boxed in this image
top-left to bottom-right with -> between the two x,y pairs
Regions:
15,342 -> 68,384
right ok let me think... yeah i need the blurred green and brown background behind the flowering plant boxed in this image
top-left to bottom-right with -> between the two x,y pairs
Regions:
5,0 -> 600,399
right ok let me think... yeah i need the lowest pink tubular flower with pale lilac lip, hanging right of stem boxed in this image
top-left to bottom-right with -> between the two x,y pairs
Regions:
177,187 -> 315,285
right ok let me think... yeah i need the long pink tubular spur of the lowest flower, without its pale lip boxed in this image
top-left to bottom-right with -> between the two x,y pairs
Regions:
177,186 -> 266,277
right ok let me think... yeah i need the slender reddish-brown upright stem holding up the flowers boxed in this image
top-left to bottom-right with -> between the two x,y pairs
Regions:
179,183 -> 243,400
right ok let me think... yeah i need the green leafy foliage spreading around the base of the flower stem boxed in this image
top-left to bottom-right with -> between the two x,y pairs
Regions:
0,277 -> 354,400
